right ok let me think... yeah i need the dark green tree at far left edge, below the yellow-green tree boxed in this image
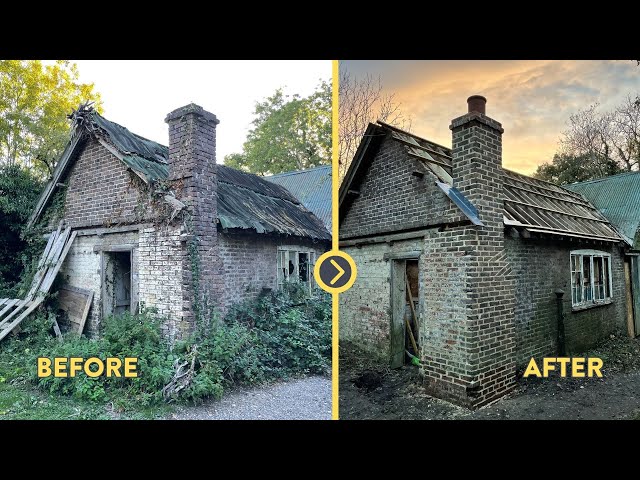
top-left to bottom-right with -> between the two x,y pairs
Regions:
0,164 -> 42,298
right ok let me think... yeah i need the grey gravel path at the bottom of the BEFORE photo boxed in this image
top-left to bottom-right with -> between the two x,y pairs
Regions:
170,377 -> 331,420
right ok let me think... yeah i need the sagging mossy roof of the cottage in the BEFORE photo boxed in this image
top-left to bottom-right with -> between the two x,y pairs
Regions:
29,108 -> 331,240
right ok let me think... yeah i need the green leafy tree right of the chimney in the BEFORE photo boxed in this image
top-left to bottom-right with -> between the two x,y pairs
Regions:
224,81 -> 331,175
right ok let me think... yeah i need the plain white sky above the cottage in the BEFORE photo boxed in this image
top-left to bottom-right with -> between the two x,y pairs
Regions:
73,60 -> 332,163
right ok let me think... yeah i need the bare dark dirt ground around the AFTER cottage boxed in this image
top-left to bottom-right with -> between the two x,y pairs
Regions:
340,336 -> 640,420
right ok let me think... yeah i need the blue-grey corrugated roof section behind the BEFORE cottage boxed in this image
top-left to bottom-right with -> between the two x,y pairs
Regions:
264,165 -> 331,232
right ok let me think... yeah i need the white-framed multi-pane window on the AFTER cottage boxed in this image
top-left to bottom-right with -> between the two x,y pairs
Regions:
571,250 -> 612,307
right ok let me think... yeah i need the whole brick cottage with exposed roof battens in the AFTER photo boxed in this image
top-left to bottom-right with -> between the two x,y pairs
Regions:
339,96 -> 630,407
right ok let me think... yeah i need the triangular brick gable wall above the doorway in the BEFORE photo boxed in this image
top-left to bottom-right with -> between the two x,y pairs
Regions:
64,138 -> 154,228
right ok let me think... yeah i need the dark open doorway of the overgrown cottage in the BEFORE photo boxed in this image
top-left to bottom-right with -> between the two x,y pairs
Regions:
102,252 -> 131,317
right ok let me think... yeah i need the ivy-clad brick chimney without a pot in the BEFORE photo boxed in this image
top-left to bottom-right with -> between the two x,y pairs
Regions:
165,103 -> 223,328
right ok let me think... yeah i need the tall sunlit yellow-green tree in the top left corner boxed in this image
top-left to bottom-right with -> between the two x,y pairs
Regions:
0,60 -> 101,177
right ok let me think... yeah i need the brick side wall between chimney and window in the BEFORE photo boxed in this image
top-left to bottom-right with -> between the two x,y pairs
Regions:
217,233 -> 327,313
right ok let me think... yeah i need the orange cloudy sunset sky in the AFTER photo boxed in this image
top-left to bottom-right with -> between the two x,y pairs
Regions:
340,60 -> 640,174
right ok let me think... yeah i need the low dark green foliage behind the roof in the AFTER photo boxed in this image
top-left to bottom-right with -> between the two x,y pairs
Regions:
533,153 -> 622,185
